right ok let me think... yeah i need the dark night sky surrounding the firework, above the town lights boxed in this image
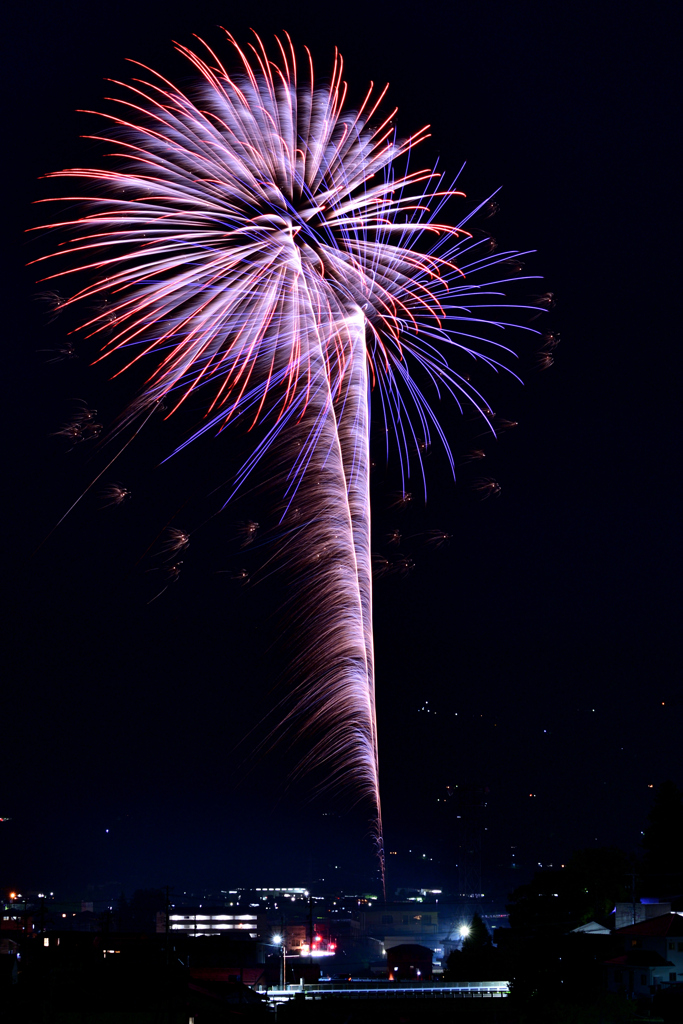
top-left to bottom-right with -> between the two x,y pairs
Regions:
0,0 -> 683,893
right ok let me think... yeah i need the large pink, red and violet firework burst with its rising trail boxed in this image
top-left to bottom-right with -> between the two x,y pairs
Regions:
31,33 -> 537,884
